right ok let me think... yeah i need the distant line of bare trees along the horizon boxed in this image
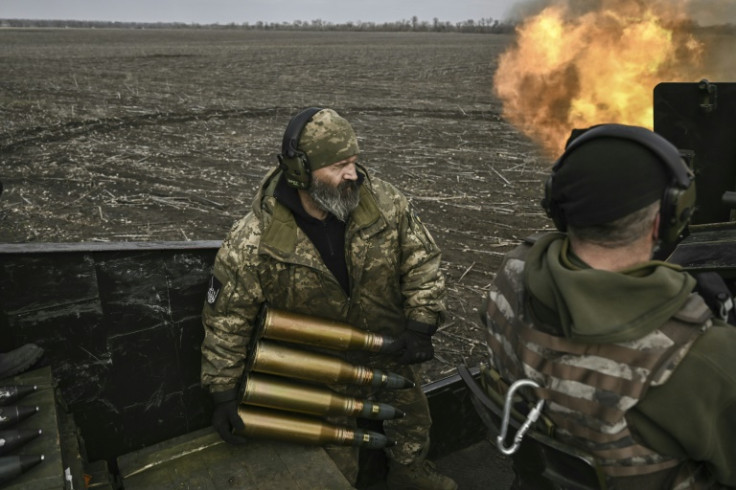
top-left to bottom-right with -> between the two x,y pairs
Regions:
0,16 -> 516,34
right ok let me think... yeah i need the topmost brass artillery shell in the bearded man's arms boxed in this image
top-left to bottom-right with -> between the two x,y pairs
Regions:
260,307 -> 395,352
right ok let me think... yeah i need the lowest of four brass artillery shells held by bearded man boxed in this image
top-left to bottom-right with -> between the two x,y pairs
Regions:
236,405 -> 395,449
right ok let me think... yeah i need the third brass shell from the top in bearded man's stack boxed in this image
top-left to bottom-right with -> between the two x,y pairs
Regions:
242,373 -> 404,420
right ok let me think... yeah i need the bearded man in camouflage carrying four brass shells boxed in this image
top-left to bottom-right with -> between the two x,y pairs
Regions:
202,108 -> 456,489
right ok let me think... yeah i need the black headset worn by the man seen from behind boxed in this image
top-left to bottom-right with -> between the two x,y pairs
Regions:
542,124 -> 695,244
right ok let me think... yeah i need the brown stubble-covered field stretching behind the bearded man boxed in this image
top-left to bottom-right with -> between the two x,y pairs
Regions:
0,29 -> 549,380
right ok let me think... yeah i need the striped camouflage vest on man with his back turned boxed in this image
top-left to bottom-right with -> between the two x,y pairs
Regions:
484,240 -> 712,482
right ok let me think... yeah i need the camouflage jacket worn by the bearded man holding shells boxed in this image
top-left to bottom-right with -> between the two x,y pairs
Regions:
202,170 -> 445,391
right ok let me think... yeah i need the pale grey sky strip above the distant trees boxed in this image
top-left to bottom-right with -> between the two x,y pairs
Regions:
0,0 -> 514,24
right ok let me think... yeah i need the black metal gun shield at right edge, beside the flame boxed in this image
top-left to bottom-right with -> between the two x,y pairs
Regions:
654,80 -> 736,290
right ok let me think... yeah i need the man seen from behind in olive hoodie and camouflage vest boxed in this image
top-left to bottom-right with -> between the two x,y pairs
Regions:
483,124 -> 736,489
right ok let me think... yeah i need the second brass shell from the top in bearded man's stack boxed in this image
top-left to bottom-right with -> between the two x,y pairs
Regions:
249,340 -> 414,389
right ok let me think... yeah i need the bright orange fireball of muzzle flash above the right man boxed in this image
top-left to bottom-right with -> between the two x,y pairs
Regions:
494,0 -> 704,155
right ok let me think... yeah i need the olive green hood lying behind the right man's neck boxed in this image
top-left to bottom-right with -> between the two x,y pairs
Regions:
524,233 -> 695,343
